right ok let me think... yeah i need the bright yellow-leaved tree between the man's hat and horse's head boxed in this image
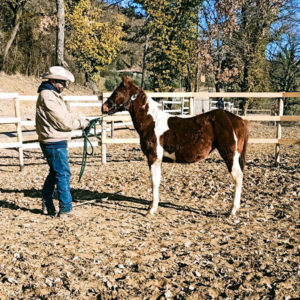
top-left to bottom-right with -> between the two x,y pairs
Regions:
66,0 -> 124,91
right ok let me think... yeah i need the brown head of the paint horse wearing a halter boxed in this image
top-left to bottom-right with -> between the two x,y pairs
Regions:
102,76 -> 140,115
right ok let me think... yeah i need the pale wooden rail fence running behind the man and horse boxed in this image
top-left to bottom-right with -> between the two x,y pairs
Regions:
0,92 -> 300,169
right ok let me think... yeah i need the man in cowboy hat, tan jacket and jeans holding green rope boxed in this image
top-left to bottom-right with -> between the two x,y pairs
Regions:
35,66 -> 89,216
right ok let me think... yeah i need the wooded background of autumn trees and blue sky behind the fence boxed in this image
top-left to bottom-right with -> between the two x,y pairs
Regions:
0,0 -> 300,114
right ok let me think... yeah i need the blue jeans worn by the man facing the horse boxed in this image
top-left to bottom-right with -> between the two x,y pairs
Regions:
40,141 -> 72,213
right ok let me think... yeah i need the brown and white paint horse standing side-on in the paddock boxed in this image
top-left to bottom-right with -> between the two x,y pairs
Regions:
102,77 -> 248,215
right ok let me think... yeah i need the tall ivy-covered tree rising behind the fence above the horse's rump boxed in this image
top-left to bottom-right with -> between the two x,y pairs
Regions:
234,0 -> 286,114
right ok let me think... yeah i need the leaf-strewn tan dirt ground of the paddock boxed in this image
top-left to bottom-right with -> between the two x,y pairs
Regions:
0,121 -> 300,299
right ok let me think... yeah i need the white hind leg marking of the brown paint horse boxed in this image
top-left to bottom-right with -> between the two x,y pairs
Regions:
231,131 -> 243,215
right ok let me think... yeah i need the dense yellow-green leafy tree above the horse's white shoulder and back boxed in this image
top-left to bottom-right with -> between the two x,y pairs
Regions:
135,0 -> 201,91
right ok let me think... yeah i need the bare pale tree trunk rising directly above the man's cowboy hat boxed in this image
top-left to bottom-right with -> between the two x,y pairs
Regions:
56,0 -> 66,66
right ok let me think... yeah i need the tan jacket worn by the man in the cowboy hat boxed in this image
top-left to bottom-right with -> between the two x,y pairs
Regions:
35,90 -> 89,143
